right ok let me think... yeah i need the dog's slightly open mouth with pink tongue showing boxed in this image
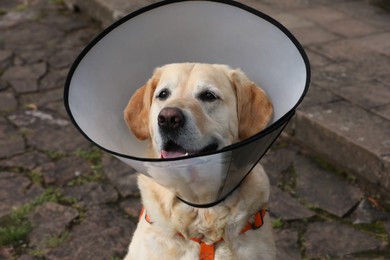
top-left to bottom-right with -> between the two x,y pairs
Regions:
161,140 -> 218,159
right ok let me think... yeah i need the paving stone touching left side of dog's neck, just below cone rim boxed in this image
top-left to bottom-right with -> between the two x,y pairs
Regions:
103,154 -> 139,197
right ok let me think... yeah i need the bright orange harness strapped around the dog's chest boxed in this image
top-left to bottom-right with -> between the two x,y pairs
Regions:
139,208 -> 267,260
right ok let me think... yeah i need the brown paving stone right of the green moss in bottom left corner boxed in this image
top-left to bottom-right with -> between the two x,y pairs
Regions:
29,202 -> 79,249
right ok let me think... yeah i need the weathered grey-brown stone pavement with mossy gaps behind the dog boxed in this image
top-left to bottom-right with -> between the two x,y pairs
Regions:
0,0 -> 390,259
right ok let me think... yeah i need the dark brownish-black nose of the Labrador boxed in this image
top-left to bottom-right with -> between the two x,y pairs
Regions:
158,107 -> 184,131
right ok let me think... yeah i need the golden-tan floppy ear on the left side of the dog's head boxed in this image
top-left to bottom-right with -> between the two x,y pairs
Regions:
124,70 -> 160,140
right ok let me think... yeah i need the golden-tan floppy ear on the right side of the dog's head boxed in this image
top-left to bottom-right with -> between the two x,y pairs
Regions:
231,69 -> 273,140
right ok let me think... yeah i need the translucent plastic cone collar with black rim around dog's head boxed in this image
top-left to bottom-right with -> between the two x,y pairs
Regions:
64,1 -> 310,207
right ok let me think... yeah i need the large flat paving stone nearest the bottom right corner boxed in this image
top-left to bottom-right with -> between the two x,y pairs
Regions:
305,222 -> 383,258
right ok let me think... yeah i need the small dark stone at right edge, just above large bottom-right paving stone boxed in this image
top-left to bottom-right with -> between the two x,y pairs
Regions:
350,199 -> 390,224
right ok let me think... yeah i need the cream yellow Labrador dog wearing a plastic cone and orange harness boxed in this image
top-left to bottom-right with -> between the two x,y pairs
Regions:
124,63 -> 275,260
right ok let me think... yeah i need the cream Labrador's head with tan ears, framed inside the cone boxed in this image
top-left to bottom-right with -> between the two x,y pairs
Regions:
124,63 -> 272,158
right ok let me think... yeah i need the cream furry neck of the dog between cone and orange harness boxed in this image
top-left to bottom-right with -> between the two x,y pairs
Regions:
139,165 -> 269,243
